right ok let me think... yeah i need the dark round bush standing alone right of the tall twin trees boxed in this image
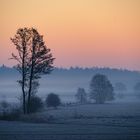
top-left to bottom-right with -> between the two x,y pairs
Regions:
46,93 -> 61,108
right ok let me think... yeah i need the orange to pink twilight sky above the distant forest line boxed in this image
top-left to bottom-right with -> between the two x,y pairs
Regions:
0,0 -> 140,70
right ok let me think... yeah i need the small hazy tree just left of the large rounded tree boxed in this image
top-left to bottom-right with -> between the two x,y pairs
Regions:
75,88 -> 87,104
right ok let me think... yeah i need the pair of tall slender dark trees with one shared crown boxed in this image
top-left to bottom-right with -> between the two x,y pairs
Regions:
11,28 -> 54,113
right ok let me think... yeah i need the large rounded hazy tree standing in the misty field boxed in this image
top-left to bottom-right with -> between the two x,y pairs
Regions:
90,74 -> 114,103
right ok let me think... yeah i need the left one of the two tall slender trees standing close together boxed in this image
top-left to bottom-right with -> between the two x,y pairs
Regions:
11,28 -> 31,114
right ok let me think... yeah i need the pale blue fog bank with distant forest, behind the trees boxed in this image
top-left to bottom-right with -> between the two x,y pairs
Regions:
0,66 -> 140,102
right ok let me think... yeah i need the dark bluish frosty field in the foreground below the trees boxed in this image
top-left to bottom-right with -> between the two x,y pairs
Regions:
0,102 -> 140,140
